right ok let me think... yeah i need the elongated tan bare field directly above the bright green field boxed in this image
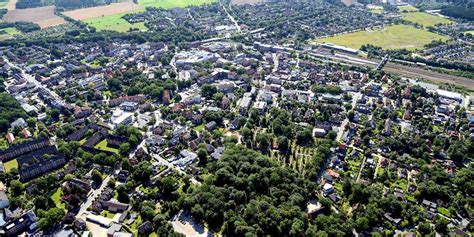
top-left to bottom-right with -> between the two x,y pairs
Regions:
64,2 -> 143,20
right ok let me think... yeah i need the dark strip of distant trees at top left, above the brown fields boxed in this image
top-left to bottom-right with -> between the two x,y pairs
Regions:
16,0 -> 117,10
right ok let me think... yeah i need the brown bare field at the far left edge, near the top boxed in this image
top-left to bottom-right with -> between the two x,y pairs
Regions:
3,6 -> 66,28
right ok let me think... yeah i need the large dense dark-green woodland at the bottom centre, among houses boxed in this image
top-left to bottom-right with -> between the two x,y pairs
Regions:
181,146 -> 308,236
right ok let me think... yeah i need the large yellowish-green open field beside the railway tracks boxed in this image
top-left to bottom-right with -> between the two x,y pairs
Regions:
315,25 -> 448,50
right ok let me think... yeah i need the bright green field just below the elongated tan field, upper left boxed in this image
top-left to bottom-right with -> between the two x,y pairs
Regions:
84,13 -> 147,32
